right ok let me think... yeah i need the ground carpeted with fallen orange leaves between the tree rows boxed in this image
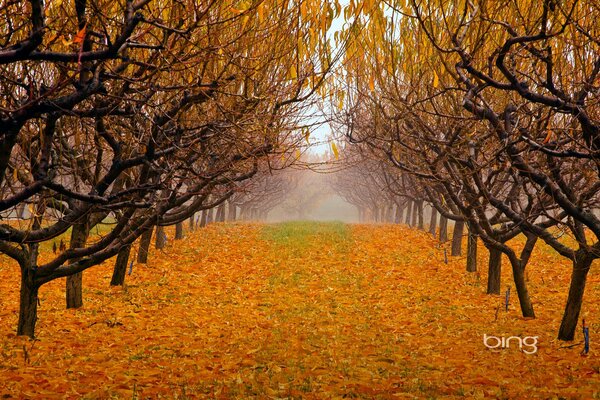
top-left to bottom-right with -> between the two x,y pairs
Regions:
0,223 -> 600,399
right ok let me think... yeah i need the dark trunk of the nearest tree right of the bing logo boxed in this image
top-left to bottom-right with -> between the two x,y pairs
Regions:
558,255 -> 593,340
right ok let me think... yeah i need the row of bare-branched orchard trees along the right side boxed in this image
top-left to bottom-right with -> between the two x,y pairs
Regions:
332,0 -> 600,340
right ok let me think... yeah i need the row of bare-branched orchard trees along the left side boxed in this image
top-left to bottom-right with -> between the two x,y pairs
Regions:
0,0 -> 350,336
